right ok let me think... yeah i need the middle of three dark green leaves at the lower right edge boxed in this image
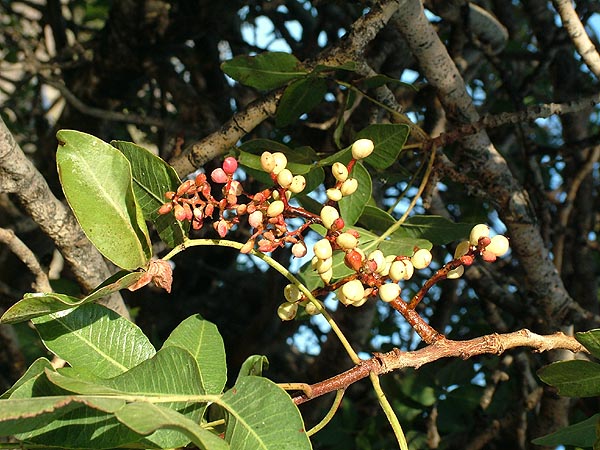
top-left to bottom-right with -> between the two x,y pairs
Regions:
538,360 -> 600,397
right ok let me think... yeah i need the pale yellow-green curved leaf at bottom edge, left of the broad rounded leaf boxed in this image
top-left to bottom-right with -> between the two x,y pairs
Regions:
115,402 -> 229,450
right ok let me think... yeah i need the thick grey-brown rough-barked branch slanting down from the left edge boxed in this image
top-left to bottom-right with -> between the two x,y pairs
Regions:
0,118 -> 129,317
